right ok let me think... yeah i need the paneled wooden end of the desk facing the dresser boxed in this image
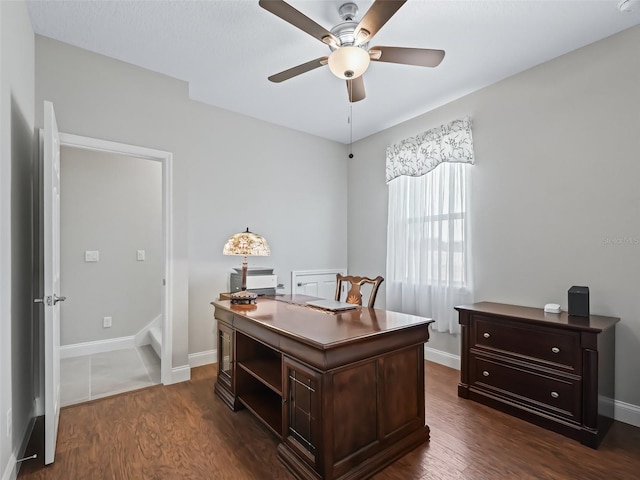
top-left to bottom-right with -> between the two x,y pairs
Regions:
325,345 -> 429,479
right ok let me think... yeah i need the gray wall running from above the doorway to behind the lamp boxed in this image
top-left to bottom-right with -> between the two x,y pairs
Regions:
36,36 -> 347,360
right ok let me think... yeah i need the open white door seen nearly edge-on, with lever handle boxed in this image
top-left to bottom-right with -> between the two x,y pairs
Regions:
42,102 -> 64,465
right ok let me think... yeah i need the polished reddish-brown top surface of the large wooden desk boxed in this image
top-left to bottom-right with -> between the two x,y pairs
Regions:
211,295 -> 433,348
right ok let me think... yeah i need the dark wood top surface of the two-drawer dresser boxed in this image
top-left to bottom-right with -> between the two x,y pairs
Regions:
455,302 -> 620,332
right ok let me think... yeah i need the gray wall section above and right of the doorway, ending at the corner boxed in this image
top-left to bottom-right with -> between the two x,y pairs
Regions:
35,36 -> 190,369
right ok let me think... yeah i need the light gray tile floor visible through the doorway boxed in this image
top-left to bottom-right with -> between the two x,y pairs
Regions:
60,345 -> 160,407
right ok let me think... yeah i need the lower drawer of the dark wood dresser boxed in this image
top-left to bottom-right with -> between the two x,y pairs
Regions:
469,355 -> 582,423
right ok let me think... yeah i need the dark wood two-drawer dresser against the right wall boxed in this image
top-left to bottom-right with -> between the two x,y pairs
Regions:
456,302 -> 620,448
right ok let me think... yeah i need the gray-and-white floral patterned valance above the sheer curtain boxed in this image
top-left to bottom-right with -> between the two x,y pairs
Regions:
387,117 -> 475,183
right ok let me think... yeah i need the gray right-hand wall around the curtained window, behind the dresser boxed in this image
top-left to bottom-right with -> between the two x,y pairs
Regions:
348,27 -> 640,406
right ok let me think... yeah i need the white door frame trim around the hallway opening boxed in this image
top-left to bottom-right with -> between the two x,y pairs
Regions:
55,132 -> 175,385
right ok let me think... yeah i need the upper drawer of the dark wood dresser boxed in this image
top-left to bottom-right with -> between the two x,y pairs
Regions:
471,315 -> 582,375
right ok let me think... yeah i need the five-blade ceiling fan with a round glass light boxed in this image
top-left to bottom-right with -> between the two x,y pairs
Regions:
259,0 -> 444,102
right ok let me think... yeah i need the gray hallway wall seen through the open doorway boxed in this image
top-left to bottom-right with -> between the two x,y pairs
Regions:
60,146 -> 164,345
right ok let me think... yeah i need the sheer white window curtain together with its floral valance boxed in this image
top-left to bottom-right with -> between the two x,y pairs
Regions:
386,119 -> 474,333
